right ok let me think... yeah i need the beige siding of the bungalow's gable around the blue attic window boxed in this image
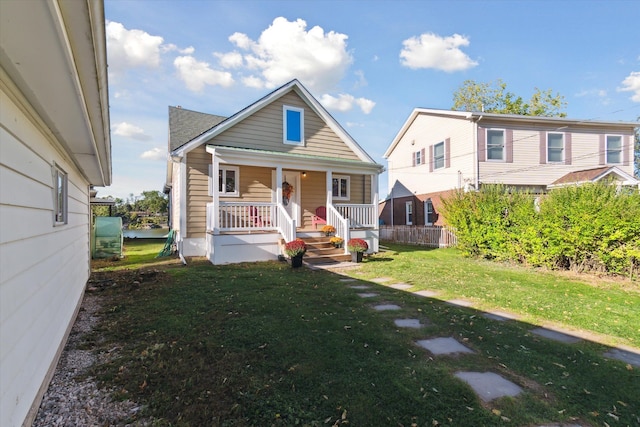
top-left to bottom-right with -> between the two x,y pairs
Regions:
208,92 -> 358,160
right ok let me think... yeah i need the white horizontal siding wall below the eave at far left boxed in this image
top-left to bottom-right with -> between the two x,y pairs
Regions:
0,82 -> 90,426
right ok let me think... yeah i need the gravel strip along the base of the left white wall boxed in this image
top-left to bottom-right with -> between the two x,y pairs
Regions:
33,289 -> 151,427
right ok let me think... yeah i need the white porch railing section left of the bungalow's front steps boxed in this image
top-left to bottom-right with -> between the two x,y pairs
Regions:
207,202 -> 277,231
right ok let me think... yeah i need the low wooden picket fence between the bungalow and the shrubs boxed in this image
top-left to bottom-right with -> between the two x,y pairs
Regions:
380,225 -> 457,248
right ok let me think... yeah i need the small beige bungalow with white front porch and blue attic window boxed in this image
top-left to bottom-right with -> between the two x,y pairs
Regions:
165,80 -> 383,264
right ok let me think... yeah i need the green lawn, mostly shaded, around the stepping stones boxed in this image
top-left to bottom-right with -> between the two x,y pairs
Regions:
86,242 -> 640,426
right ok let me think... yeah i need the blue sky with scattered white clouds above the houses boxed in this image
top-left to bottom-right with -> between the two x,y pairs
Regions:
102,0 -> 640,200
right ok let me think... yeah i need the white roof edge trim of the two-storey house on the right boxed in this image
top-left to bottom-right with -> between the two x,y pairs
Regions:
383,108 -> 640,159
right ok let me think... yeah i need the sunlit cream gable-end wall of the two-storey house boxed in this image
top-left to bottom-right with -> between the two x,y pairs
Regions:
388,114 -> 475,197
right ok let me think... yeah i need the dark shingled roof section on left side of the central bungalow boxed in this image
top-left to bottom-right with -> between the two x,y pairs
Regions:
169,106 -> 227,152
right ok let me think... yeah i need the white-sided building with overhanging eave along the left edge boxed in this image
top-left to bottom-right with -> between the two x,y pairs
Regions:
0,0 -> 111,427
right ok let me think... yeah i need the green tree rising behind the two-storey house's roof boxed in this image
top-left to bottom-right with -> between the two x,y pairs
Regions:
451,79 -> 567,117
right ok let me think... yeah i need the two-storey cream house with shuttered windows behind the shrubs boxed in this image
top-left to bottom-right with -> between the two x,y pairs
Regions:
380,108 -> 640,225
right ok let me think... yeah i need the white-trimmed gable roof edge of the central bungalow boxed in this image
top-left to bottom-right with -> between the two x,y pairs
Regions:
169,79 -> 375,164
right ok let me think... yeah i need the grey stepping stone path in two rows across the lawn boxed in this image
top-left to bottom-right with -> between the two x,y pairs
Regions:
340,277 -> 640,416
